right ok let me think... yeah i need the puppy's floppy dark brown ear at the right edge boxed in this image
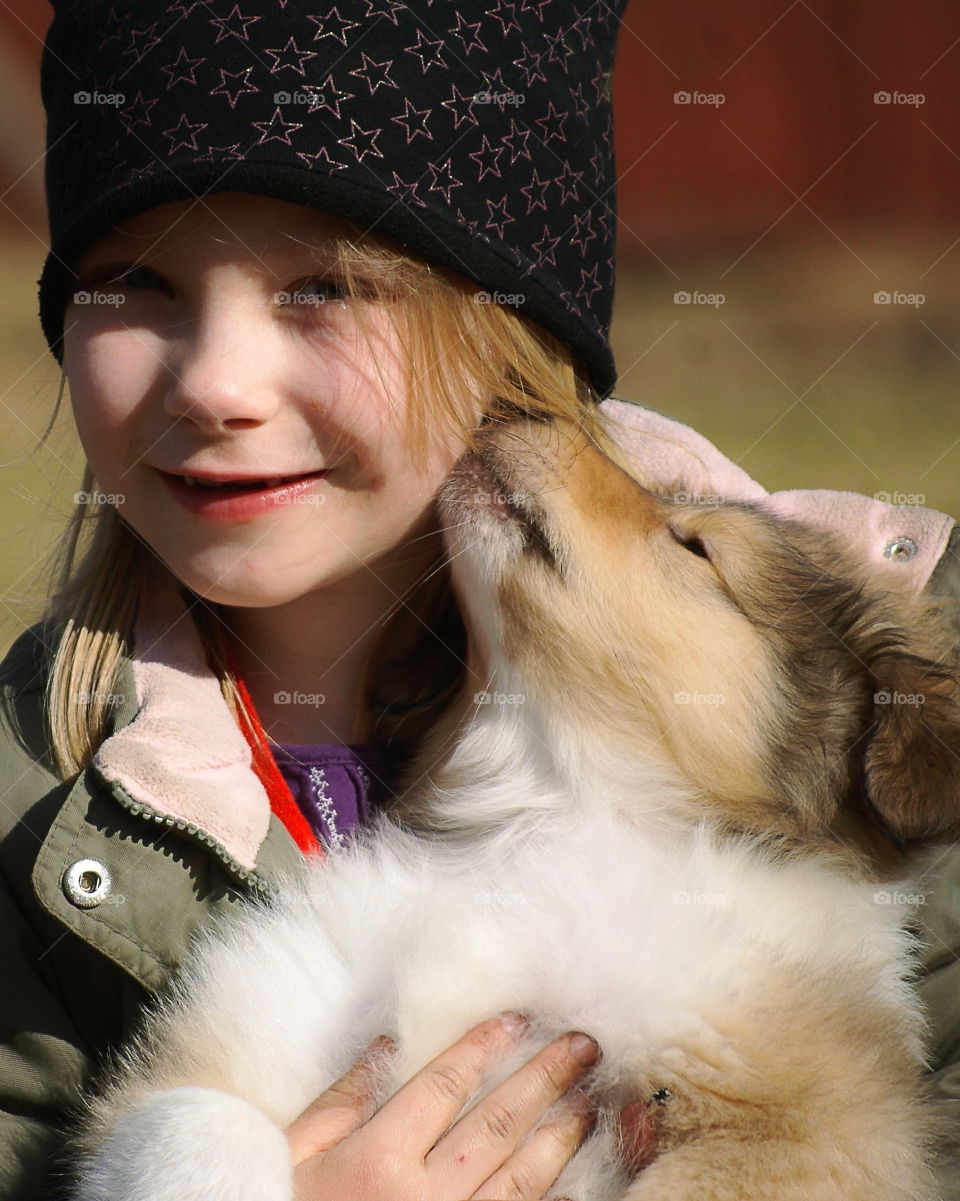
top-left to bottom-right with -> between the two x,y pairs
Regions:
864,649 -> 960,843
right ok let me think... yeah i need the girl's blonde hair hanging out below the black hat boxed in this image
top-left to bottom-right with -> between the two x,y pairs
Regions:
43,222 -> 609,778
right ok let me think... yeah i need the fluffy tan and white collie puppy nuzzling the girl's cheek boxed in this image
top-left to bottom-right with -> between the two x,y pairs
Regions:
76,422 -> 960,1201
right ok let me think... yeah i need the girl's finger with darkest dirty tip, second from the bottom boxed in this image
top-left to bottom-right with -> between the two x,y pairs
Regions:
427,1033 -> 598,1196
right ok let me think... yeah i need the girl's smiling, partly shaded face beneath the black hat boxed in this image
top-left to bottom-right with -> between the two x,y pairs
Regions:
64,192 -> 463,607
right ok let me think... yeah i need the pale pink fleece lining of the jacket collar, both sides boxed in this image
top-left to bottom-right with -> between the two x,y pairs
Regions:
94,399 -> 954,868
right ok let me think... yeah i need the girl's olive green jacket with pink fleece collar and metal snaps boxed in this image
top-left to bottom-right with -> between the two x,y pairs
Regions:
0,402 -> 960,1201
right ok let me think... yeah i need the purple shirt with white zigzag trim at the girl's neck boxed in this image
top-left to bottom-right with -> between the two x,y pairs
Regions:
270,742 -> 390,850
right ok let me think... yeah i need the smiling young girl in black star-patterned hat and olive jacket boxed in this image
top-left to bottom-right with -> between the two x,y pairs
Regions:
7,0 -> 960,1201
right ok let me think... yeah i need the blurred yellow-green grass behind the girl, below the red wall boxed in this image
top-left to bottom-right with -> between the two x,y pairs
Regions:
0,231 -> 960,646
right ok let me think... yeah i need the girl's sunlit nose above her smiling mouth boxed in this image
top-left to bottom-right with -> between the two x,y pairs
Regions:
166,289 -> 280,432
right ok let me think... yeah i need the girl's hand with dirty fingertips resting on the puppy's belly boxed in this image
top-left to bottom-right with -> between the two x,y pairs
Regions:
287,1017 -> 607,1201
